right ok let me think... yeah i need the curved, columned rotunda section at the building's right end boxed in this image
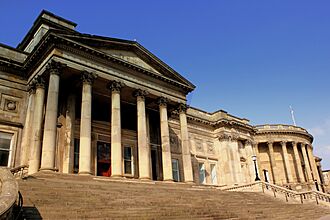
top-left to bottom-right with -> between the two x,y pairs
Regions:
254,125 -> 320,189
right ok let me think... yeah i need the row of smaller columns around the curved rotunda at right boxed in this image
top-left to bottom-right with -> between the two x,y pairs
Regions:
255,141 -> 321,184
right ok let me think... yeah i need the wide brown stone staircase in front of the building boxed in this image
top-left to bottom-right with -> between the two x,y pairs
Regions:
18,173 -> 330,219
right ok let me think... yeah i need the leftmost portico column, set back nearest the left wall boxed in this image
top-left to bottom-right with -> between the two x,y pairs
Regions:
21,85 -> 36,165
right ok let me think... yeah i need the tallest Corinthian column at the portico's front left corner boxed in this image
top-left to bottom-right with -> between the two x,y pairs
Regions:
40,61 -> 63,170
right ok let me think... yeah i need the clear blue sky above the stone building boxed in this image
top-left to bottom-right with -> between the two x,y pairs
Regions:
0,0 -> 330,169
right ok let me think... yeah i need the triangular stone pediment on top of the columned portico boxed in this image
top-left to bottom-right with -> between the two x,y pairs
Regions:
57,33 -> 195,91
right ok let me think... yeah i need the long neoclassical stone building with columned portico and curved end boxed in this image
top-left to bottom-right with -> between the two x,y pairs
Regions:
0,11 -> 321,189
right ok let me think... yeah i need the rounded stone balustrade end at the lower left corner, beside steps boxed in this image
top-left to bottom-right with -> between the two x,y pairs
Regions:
0,168 -> 18,220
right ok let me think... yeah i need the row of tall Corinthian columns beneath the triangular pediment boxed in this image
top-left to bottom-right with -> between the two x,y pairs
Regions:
23,61 -> 193,182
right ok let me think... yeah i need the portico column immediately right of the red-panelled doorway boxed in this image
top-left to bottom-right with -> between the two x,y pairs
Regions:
109,81 -> 123,177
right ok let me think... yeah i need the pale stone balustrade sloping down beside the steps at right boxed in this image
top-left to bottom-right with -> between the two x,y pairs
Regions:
222,181 -> 330,206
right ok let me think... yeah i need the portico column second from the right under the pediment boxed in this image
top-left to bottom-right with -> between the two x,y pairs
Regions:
158,97 -> 173,181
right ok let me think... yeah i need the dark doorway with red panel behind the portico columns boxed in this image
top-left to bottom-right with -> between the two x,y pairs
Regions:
97,141 -> 111,177
